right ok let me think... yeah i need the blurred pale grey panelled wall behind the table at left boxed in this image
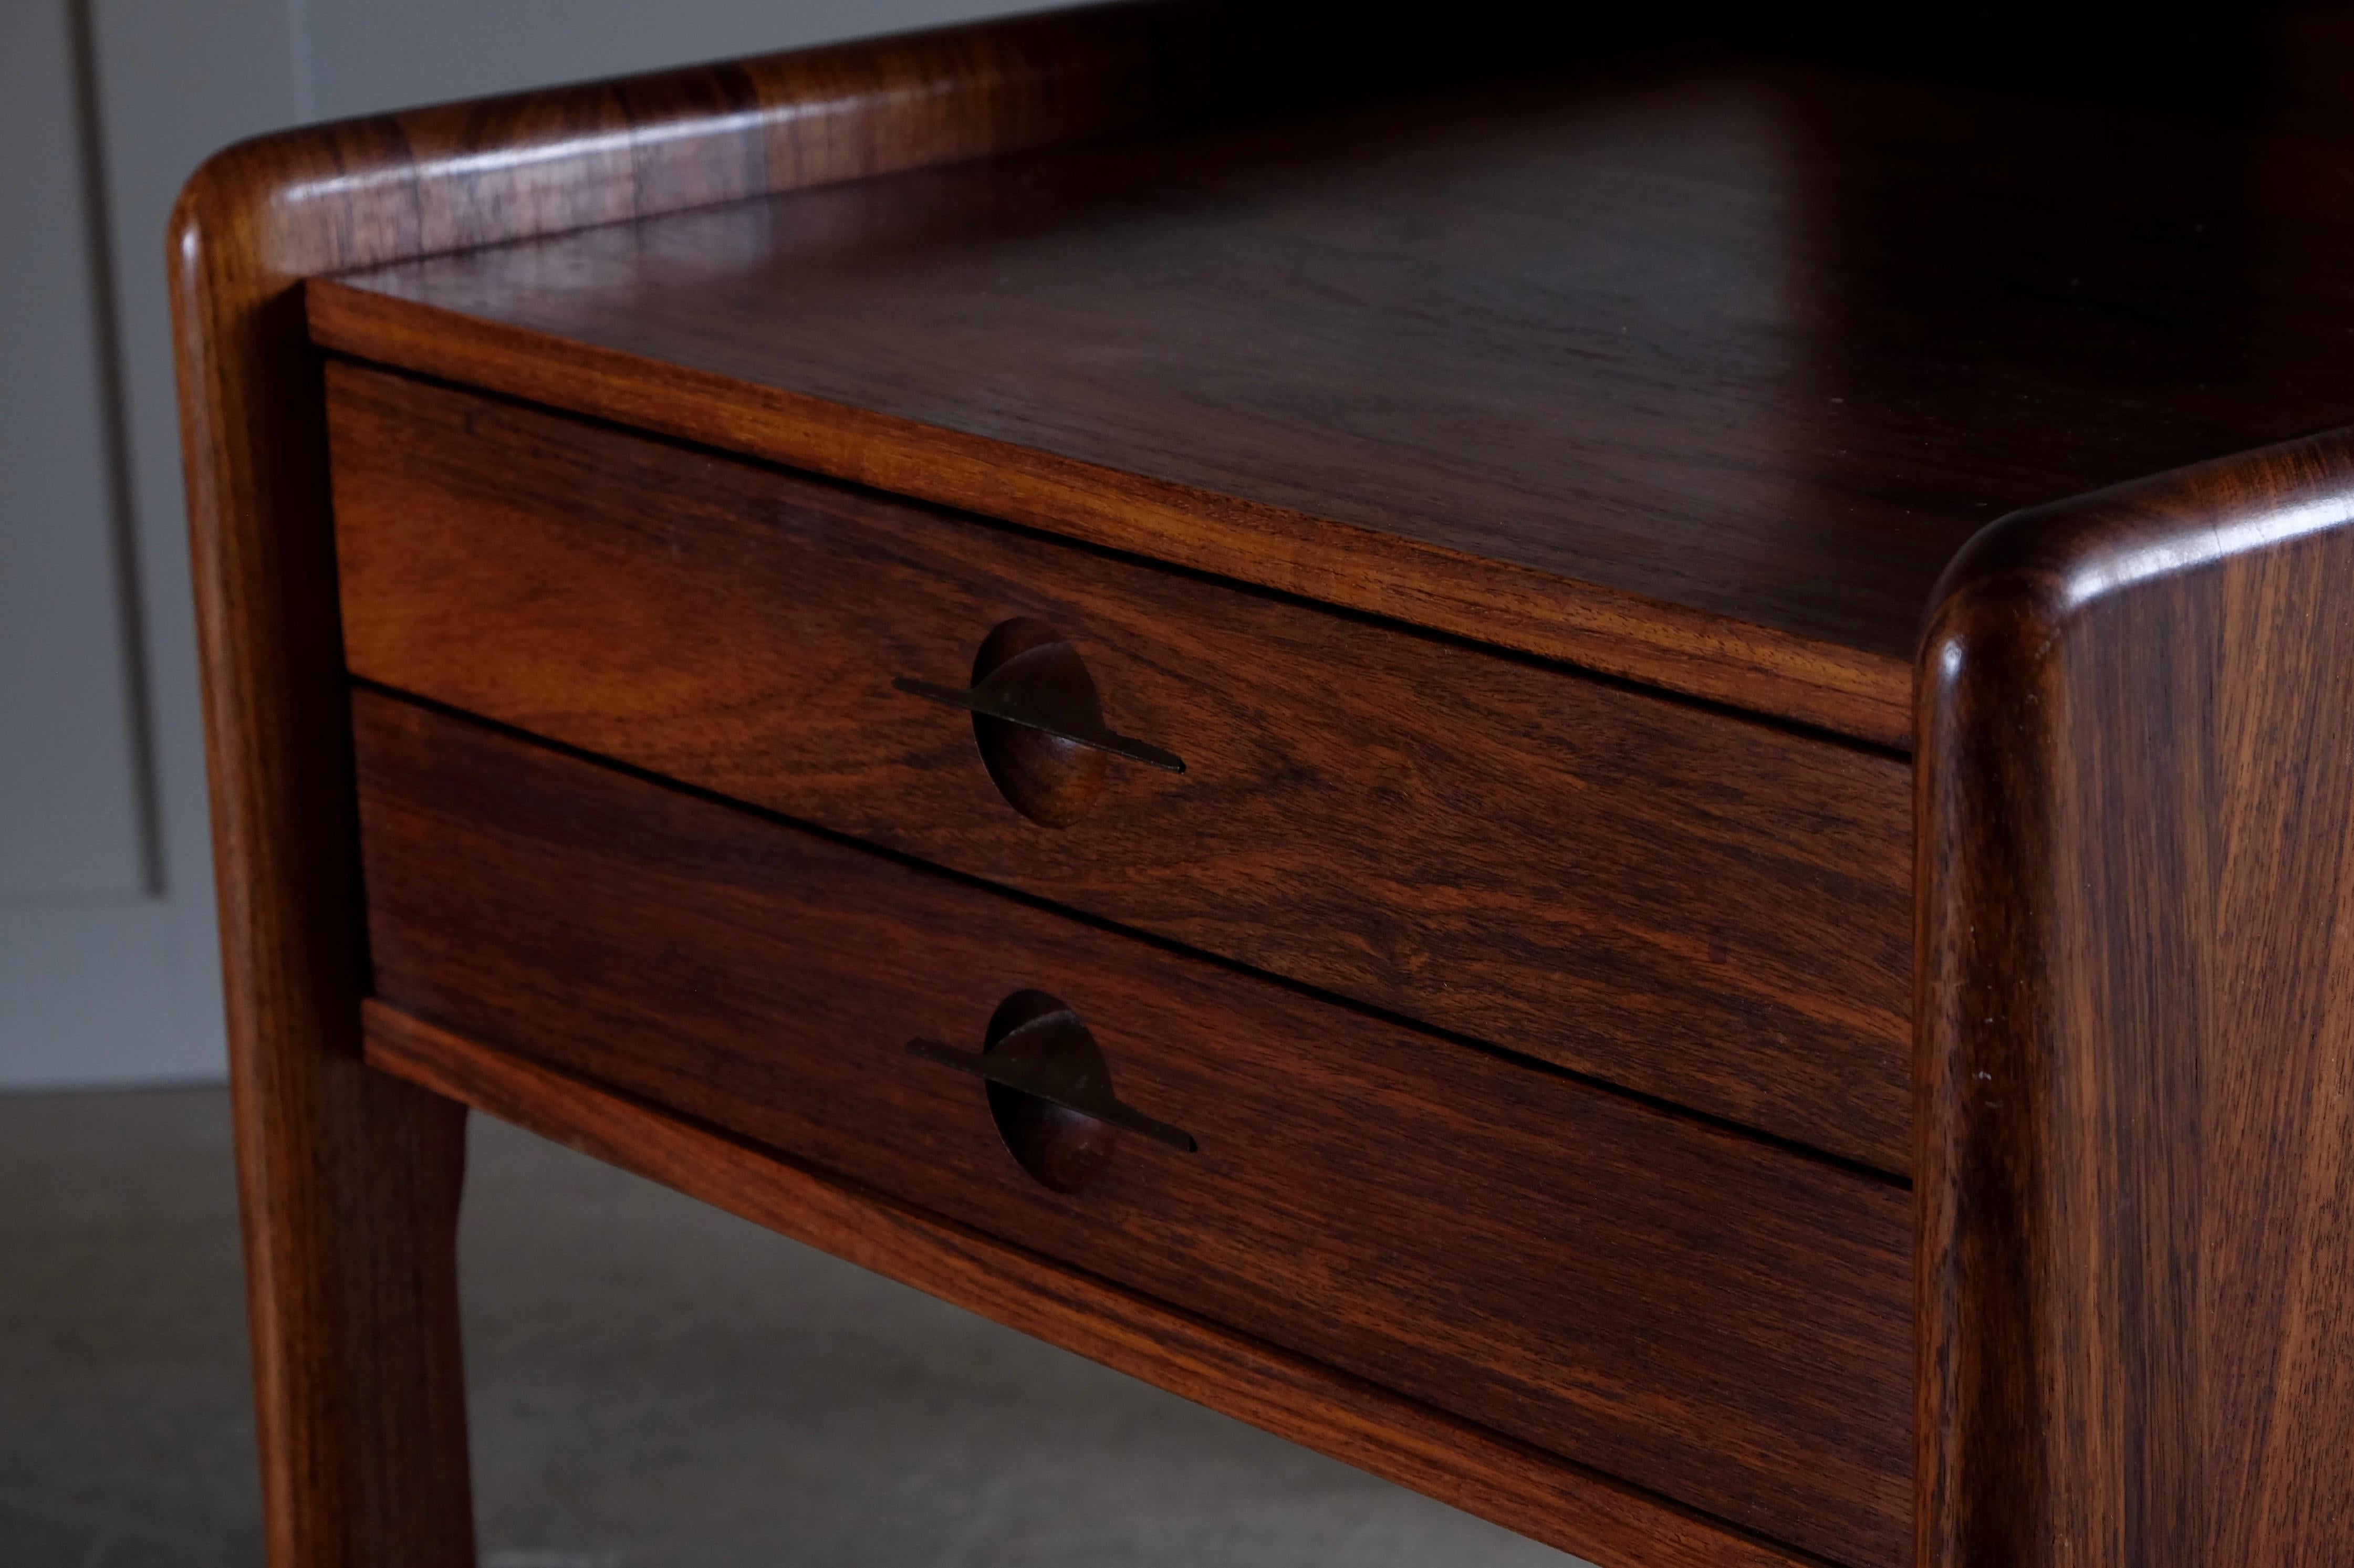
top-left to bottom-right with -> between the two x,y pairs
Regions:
0,0 -> 1031,1088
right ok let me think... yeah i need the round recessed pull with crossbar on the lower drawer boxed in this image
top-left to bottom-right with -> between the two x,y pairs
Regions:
907,991 -> 1198,1191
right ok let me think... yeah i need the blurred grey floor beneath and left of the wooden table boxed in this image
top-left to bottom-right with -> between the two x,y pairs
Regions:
0,1090 -> 1575,1568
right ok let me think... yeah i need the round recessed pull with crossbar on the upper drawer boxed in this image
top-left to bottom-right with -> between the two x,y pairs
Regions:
892,619 -> 1184,827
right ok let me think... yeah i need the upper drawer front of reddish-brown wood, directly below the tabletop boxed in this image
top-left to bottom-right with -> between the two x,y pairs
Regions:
327,365 -> 1911,1170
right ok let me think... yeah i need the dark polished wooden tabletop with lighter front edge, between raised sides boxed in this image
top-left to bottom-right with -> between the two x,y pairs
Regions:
311,52 -> 2354,746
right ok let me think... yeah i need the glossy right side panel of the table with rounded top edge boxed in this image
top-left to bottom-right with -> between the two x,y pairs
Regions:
1919,431 -> 2354,1568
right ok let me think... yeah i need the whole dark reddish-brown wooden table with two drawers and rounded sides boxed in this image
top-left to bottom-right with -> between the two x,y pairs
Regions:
172,5 -> 2354,1568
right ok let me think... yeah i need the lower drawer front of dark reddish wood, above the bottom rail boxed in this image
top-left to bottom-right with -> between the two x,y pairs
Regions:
356,692 -> 1911,1563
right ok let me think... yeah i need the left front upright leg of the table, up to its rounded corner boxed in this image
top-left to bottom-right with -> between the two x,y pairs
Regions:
172,103 -> 473,1568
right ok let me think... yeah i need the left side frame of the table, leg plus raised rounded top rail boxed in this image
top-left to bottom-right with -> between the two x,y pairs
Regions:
170,2 -> 1412,1568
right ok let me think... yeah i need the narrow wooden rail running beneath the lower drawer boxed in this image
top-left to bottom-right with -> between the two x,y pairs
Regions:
365,1000 -> 1822,1568
